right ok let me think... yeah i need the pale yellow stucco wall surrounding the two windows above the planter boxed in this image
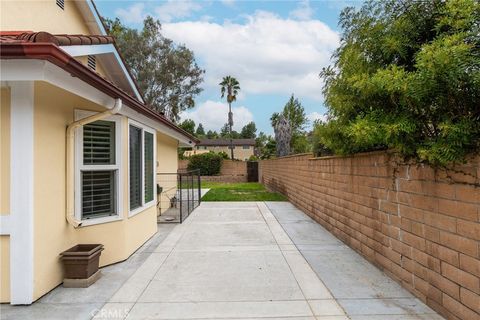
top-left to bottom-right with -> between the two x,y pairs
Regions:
31,82 -> 159,299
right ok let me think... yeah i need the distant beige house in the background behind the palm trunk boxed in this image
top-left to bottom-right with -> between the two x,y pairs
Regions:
184,139 -> 255,160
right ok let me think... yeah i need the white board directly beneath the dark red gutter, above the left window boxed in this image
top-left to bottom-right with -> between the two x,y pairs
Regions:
0,59 -> 115,109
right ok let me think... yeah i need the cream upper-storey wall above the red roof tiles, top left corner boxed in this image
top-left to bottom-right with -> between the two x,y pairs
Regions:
0,0 -> 90,34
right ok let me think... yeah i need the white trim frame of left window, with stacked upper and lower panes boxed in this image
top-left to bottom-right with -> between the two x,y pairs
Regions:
75,110 -> 124,227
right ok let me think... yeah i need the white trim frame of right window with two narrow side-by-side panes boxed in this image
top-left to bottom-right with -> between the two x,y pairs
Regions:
127,119 -> 157,218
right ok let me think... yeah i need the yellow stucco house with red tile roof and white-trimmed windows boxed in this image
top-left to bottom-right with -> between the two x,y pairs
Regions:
0,0 -> 195,304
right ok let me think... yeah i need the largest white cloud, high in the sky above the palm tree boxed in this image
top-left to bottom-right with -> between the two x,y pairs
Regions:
163,11 -> 339,101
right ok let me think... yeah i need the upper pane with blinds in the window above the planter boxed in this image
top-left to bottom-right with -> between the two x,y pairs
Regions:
83,121 -> 115,164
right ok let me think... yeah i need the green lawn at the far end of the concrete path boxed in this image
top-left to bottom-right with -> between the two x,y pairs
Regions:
202,182 -> 286,201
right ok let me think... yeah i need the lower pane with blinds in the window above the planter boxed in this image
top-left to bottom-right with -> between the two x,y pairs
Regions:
81,170 -> 116,219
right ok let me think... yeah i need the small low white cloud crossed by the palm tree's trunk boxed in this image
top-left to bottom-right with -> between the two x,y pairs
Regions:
180,100 -> 253,132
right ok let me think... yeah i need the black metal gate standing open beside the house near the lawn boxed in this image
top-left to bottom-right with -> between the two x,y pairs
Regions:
157,170 -> 201,223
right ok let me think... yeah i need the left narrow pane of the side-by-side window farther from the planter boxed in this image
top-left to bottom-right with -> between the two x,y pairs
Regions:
129,126 -> 142,210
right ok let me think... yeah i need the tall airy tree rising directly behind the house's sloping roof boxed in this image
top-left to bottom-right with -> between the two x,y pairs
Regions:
104,17 -> 204,121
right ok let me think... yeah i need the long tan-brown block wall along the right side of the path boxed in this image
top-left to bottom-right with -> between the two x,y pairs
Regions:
259,152 -> 480,320
